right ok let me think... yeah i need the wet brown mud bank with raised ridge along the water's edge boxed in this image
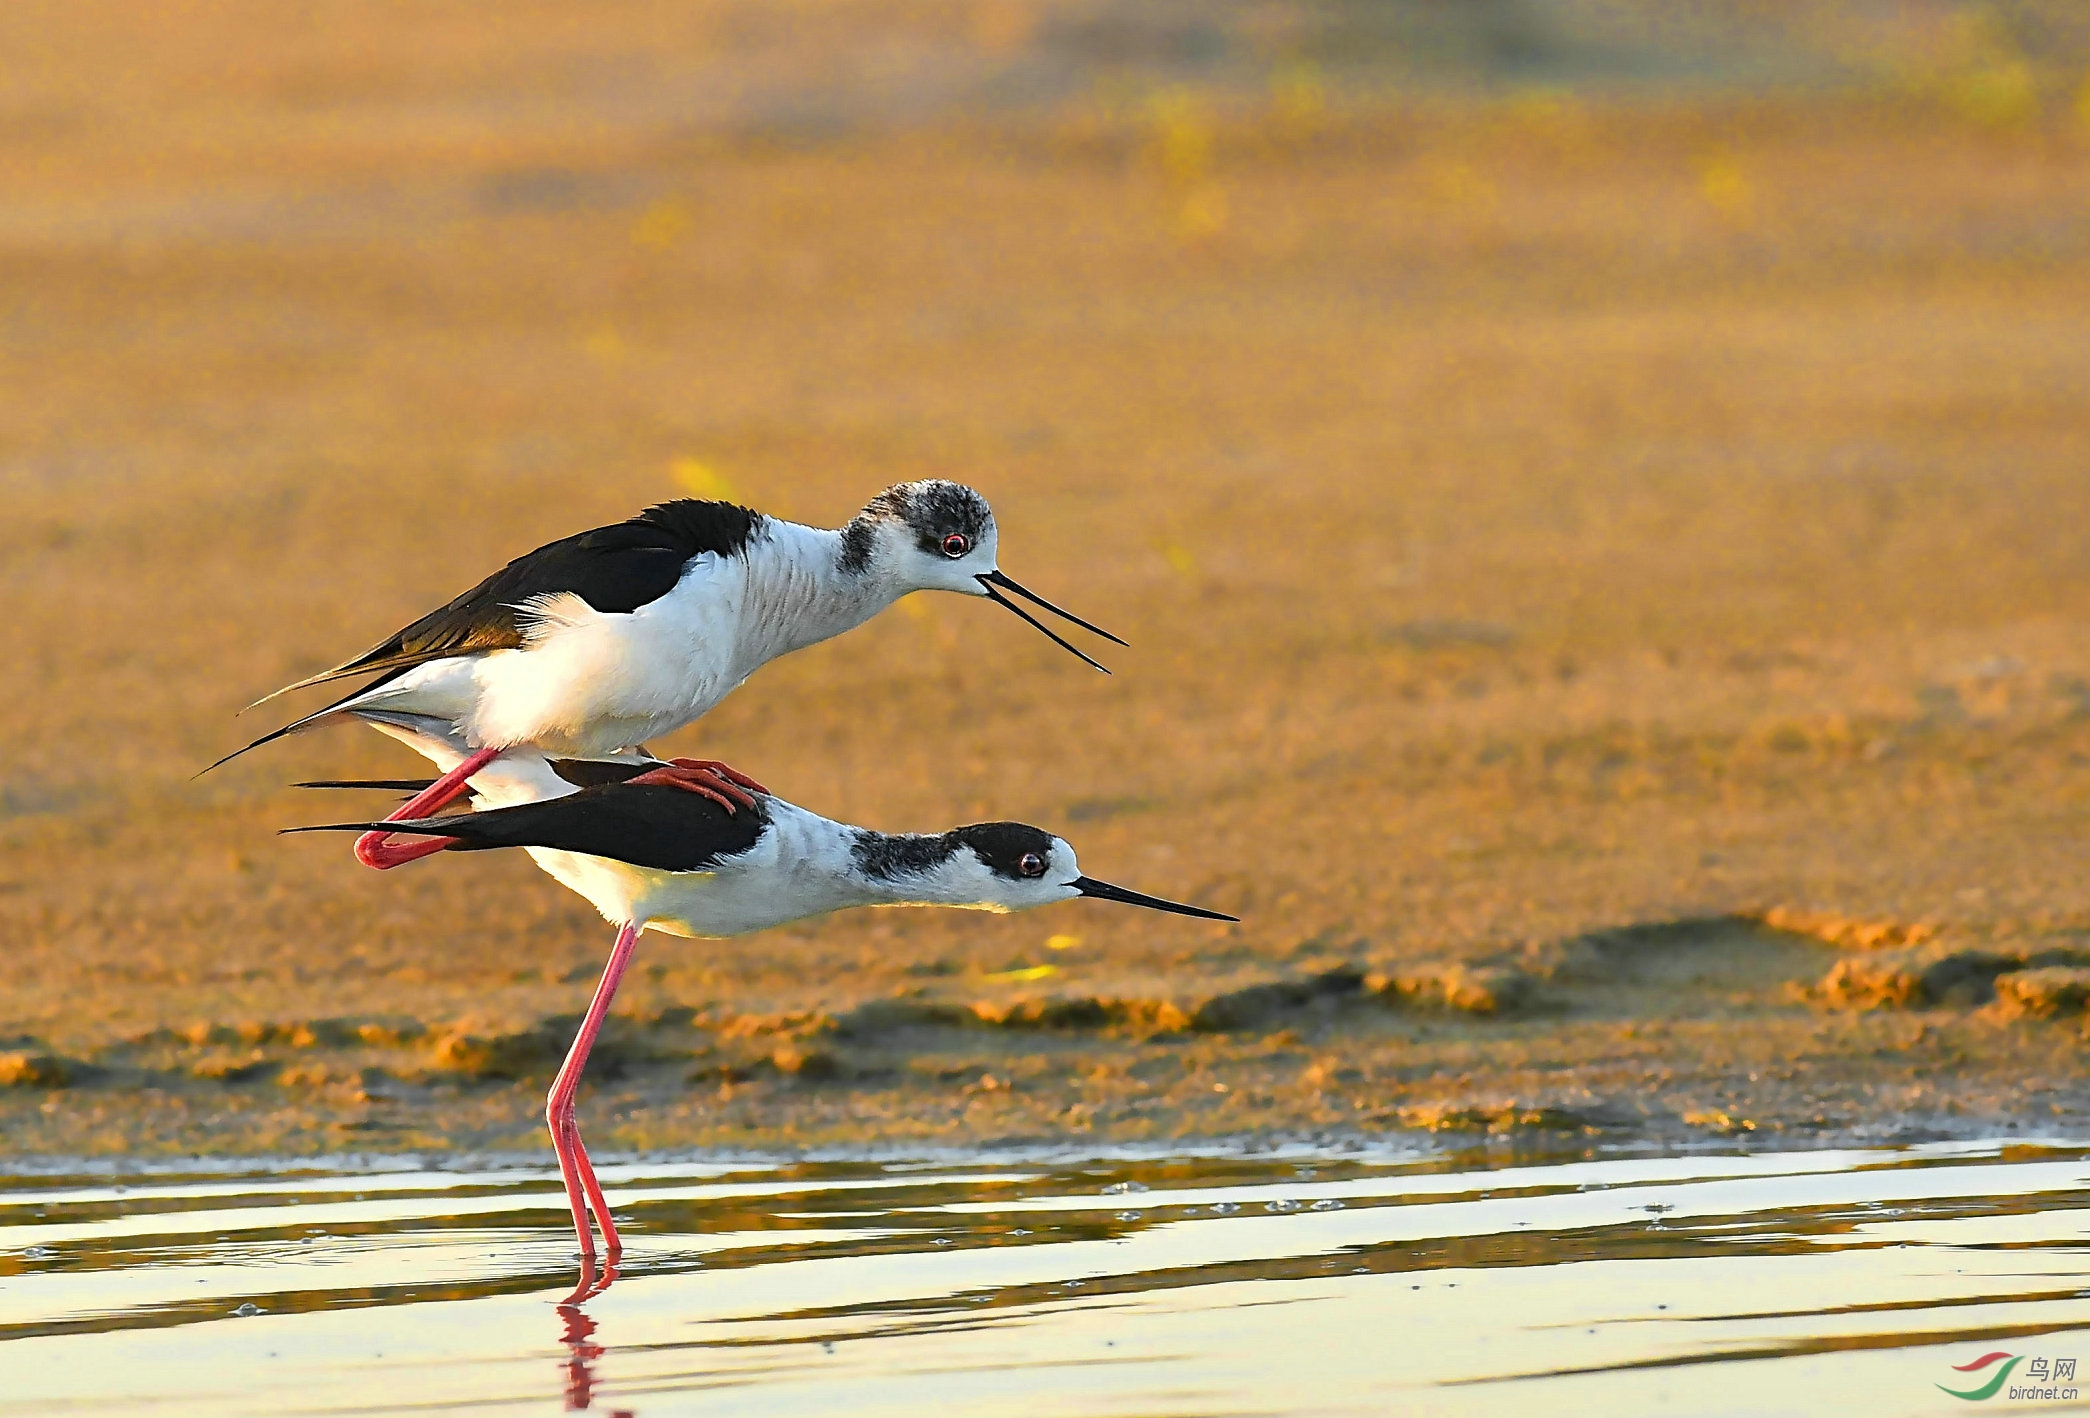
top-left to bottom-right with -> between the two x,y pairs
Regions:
12,908 -> 2090,1154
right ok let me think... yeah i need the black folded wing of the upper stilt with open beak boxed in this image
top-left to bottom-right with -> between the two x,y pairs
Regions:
261,498 -> 761,703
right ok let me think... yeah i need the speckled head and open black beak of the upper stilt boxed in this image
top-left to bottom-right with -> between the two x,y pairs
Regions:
842,479 -> 1124,673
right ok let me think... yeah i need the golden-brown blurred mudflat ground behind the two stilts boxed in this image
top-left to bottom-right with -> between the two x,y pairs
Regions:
0,0 -> 2090,1150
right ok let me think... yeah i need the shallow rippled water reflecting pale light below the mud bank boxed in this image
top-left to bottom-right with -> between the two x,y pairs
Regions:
0,1144 -> 2090,1416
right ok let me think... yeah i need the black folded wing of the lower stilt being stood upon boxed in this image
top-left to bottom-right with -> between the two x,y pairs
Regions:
288,782 -> 769,872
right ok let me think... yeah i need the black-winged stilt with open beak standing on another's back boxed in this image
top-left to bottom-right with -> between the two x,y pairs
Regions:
205,481 -> 1124,868
